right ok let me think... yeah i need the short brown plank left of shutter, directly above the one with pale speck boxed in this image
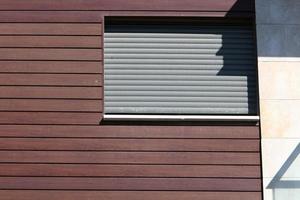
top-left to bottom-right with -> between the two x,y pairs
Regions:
0,61 -> 103,74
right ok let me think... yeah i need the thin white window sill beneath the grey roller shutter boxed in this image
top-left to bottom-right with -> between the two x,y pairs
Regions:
104,114 -> 259,121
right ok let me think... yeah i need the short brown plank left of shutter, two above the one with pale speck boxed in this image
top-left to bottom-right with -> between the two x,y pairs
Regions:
0,48 -> 102,61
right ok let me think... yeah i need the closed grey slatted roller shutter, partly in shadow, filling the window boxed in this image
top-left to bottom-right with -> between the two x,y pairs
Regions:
104,20 -> 257,115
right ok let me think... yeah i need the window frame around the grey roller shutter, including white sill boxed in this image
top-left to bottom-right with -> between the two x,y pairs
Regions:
102,14 -> 260,122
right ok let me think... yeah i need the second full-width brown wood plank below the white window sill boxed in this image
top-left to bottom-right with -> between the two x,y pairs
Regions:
0,138 -> 259,152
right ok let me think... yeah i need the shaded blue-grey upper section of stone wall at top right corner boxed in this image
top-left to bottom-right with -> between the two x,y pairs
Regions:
256,0 -> 300,57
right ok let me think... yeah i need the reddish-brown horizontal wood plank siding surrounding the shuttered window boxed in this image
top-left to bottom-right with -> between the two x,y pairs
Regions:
0,0 -> 261,200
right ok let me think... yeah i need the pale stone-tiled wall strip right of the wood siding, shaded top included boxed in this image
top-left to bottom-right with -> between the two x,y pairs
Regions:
256,0 -> 300,200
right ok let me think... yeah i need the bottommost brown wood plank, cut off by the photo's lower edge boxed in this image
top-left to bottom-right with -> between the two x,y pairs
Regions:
0,190 -> 261,200
